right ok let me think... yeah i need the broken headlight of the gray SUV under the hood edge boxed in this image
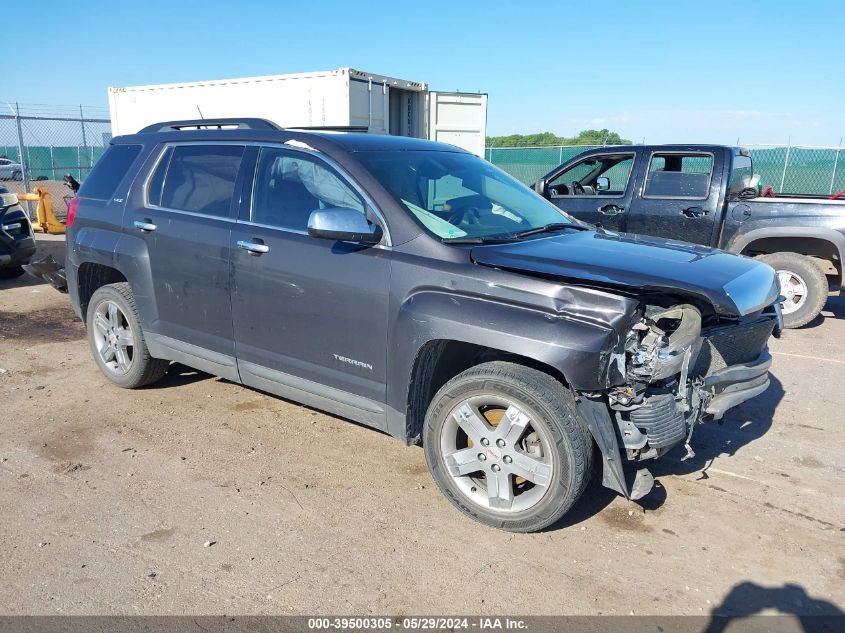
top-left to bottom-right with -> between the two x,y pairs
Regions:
625,304 -> 701,383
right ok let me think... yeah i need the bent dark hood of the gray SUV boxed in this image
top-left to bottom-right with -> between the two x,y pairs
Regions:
471,231 -> 779,316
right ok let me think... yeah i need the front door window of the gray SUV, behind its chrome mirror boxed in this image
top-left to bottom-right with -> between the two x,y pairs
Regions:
250,147 -> 366,233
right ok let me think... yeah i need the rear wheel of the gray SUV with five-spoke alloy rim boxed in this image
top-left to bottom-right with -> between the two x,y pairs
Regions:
85,282 -> 169,389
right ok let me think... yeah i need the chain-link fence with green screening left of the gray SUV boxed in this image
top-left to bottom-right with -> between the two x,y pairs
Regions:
0,104 -> 111,219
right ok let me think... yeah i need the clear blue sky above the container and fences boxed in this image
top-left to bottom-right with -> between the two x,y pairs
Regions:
6,0 -> 845,146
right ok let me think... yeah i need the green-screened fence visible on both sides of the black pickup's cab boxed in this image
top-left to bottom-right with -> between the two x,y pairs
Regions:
485,145 -> 845,195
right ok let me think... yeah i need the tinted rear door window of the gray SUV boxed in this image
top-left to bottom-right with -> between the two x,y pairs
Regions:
157,144 -> 244,218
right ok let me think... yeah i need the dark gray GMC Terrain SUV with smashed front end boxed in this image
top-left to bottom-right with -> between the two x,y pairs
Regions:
66,119 -> 781,532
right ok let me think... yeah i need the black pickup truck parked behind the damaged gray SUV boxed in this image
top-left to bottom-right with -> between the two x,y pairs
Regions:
534,145 -> 845,328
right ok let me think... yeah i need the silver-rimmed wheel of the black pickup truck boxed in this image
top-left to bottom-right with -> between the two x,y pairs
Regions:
760,253 -> 829,328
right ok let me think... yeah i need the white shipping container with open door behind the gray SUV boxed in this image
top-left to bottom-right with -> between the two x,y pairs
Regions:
109,68 -> 487,157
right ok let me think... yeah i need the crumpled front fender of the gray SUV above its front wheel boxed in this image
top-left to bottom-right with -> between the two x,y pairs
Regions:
387,291 -> 627,443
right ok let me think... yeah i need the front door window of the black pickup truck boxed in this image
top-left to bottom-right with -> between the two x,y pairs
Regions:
549,154 -> 634,198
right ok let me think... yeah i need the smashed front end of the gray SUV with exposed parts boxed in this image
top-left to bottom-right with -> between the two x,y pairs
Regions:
578,287 -> 783,499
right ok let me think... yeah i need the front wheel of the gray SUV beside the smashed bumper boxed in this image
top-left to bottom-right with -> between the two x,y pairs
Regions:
423,361 -> 593,532
